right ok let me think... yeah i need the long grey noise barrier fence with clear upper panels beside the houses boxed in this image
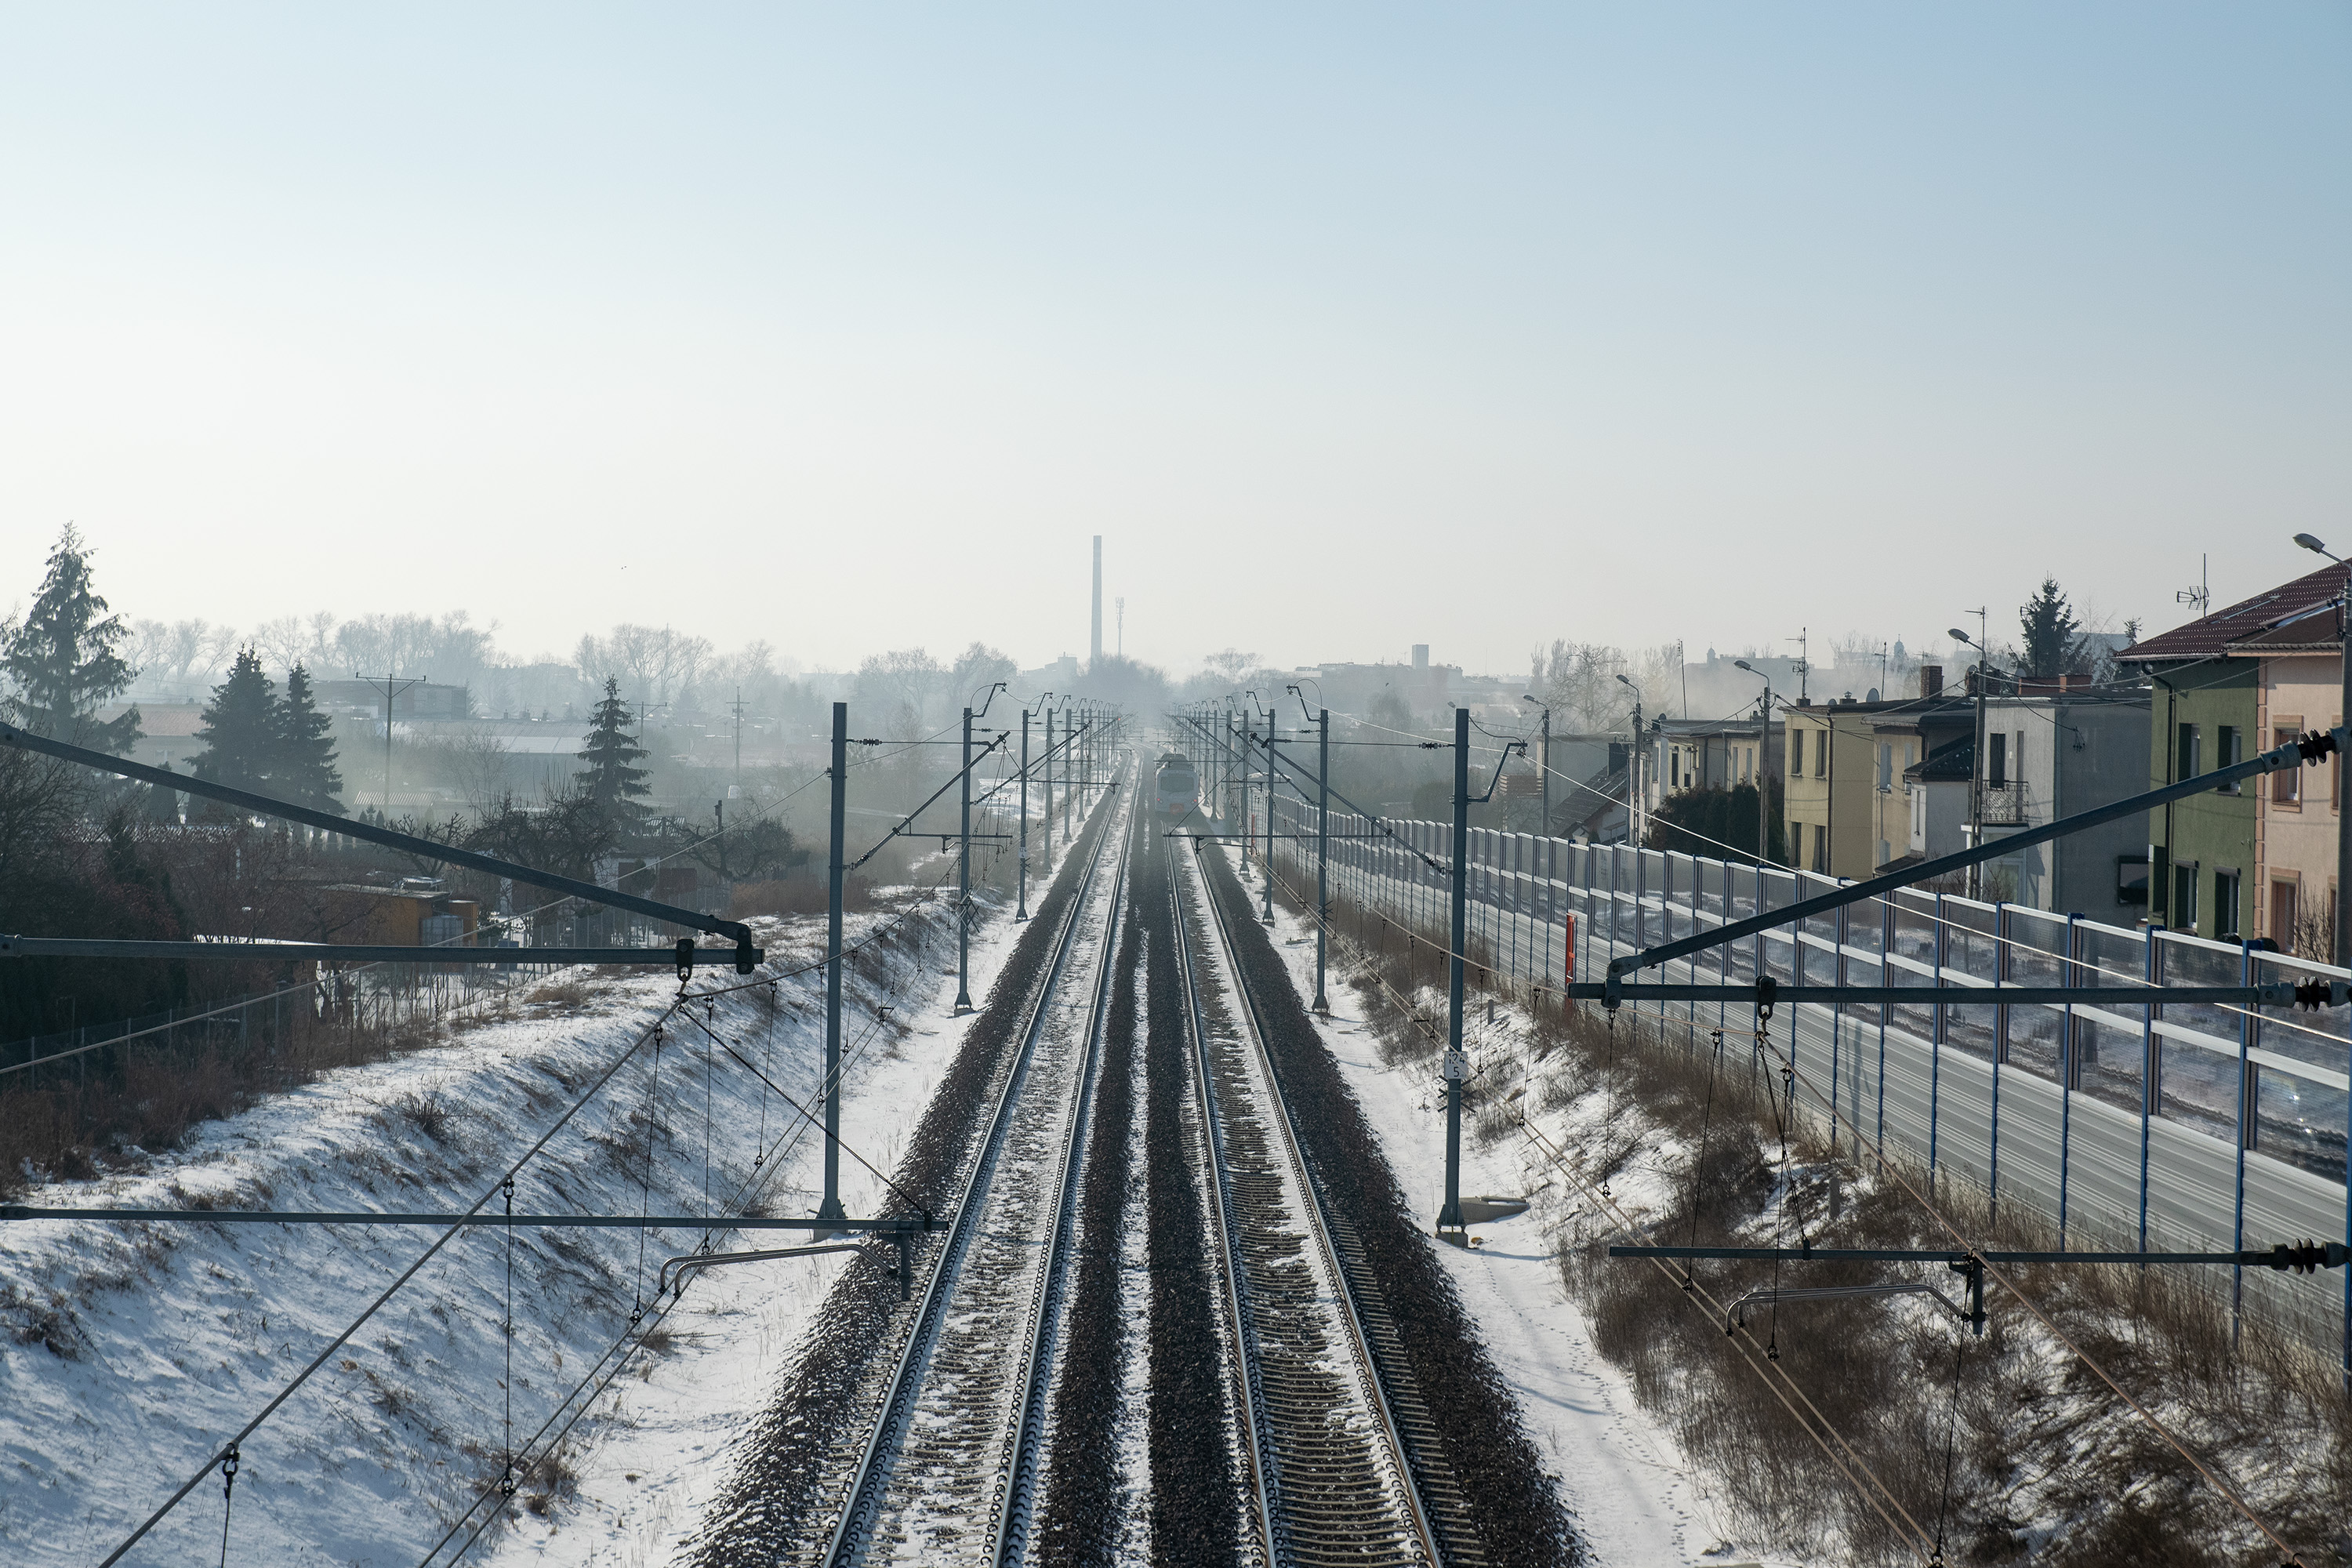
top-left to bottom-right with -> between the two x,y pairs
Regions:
1275,799 -> 2352,1354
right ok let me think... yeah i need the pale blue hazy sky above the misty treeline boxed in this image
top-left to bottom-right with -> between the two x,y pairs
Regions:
0,0 -> 2352,670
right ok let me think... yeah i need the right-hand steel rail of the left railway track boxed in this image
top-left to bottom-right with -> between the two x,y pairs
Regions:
988,767 -> 1143,1568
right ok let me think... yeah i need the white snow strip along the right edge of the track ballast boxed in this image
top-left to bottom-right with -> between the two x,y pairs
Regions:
1223,851 -> 1766,1568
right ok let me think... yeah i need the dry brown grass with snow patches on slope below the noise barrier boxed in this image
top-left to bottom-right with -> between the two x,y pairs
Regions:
1334,865 -> 2352,1568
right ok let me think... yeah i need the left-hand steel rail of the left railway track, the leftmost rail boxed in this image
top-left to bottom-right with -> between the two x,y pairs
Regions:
818,761 -> 1129,1568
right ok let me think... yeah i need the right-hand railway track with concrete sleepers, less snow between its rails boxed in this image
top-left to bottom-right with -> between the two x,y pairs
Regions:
1164,848 -> 1484,1568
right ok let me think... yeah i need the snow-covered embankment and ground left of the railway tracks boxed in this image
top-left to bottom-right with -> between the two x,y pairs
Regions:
0,884 -> 1016,1566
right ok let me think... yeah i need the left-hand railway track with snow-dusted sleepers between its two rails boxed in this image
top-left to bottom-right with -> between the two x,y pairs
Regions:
816,766 -> 1134,1568
